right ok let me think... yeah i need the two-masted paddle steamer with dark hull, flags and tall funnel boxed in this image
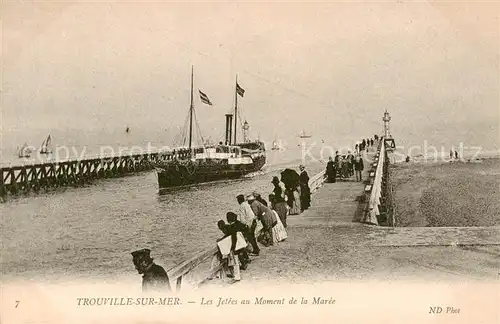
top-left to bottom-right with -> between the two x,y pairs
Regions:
155,69 -> 266,189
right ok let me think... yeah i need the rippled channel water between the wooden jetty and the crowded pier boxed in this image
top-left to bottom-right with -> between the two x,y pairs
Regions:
0,140 -> 324,281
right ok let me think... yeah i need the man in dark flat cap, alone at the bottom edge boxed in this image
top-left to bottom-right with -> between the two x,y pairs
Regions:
132,249 -> 170,292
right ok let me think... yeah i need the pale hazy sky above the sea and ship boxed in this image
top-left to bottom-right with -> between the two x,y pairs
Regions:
1,1 -> 500,157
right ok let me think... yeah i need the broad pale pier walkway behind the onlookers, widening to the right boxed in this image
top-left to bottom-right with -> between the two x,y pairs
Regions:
201,157 -> 500,286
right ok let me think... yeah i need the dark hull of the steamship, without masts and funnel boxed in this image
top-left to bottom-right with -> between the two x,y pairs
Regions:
157,155 -> 266,189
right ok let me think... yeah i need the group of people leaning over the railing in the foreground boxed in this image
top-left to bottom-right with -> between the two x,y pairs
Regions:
212,165 -> 311,282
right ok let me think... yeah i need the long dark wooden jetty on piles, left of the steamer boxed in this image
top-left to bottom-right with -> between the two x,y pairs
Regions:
0,148 -> 201,198
